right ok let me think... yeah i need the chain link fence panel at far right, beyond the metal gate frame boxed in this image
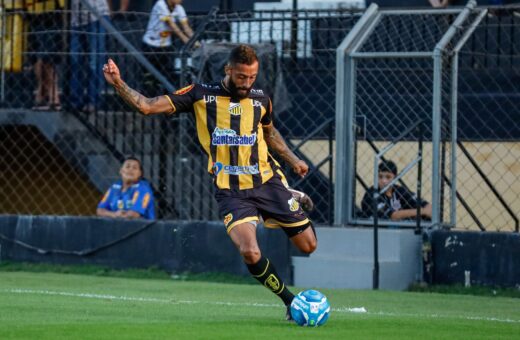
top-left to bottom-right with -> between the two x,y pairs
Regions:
456,7 -> 520,232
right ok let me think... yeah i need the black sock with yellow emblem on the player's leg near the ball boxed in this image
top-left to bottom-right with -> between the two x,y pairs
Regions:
247,256 -> 294,306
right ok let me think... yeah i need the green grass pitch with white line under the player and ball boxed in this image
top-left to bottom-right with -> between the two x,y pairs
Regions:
0,271 -> 520,339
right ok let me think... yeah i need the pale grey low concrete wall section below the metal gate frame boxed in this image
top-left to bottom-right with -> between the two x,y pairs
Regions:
293,228 -> 421,290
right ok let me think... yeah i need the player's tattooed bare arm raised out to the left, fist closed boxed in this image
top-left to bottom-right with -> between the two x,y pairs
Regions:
103,59 -> 174,115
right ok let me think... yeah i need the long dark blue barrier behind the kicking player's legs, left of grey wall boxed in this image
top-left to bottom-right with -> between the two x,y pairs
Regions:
0,216 -> 292,283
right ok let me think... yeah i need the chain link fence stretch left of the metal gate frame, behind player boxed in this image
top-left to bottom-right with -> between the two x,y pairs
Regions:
0,1 -> 361,223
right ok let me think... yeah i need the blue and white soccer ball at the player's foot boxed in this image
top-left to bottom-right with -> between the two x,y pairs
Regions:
291,289 -> 330,327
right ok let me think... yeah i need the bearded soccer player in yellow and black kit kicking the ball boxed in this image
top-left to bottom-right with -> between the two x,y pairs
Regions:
103,45 -> 317,320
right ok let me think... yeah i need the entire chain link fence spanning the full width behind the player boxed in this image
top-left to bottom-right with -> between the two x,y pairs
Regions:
0,0 -> 520,231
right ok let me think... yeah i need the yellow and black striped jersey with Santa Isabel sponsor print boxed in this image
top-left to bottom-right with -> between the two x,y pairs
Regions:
166,82 -> 274,190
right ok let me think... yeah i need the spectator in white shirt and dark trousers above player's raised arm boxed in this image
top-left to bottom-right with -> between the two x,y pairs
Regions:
142,0 -> 193,91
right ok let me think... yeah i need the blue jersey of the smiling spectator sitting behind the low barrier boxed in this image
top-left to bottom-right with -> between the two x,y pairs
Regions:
98,180 -> 155,220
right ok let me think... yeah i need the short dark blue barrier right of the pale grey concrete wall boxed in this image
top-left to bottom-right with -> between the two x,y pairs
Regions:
432,231 -> 520,287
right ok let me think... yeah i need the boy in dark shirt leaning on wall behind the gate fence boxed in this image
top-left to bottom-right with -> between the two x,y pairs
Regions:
361,161 -> 432,220
